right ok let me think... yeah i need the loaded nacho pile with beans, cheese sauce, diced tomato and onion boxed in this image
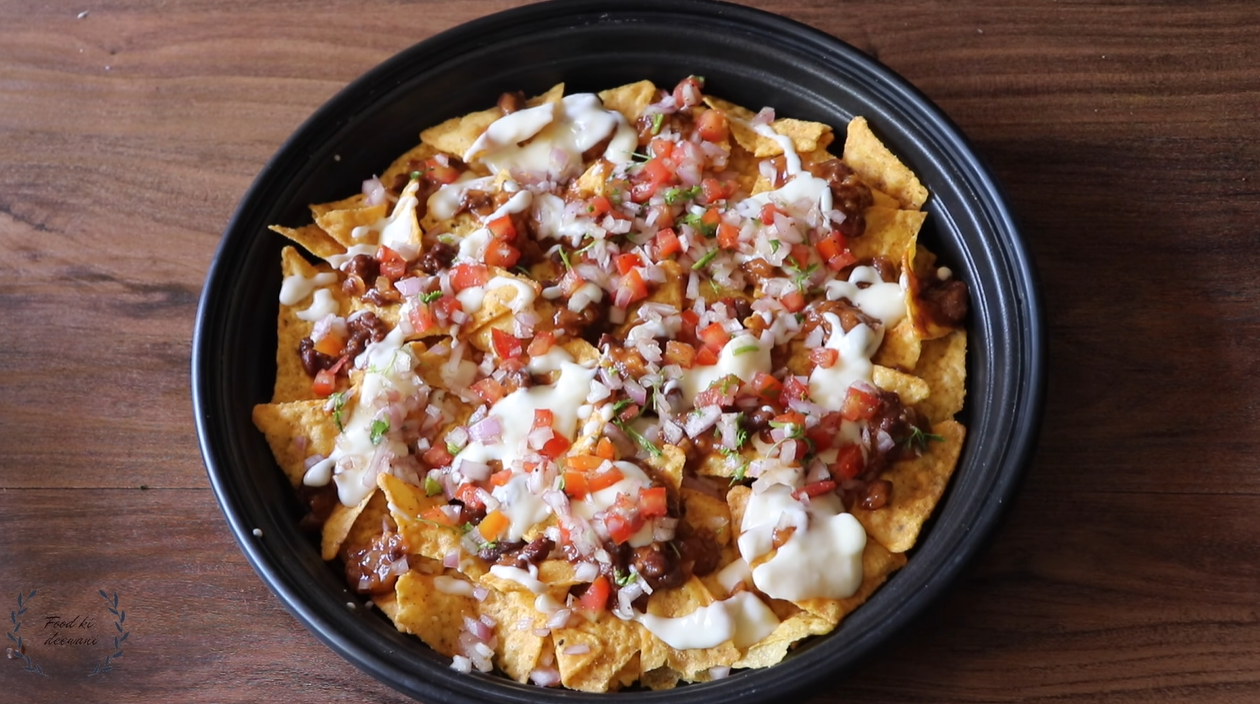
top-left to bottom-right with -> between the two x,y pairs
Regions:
253,77 -> 968,691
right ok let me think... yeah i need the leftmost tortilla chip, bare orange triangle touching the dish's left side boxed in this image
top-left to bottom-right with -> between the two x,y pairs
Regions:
253,399 -> 340,486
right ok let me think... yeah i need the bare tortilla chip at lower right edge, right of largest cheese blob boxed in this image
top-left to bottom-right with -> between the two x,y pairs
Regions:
853,421 -> 966,553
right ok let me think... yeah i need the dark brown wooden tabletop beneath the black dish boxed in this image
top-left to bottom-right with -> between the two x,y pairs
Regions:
0,0 -> 1260,704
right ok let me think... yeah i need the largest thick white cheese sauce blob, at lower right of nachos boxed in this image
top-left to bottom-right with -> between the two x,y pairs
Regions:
738,484 -> 867,601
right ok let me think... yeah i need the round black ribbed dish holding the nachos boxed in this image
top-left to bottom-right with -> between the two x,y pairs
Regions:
193,0 -> 1045,703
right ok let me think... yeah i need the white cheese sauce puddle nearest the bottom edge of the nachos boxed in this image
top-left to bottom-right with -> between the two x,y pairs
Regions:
635,592 -> 779,650
